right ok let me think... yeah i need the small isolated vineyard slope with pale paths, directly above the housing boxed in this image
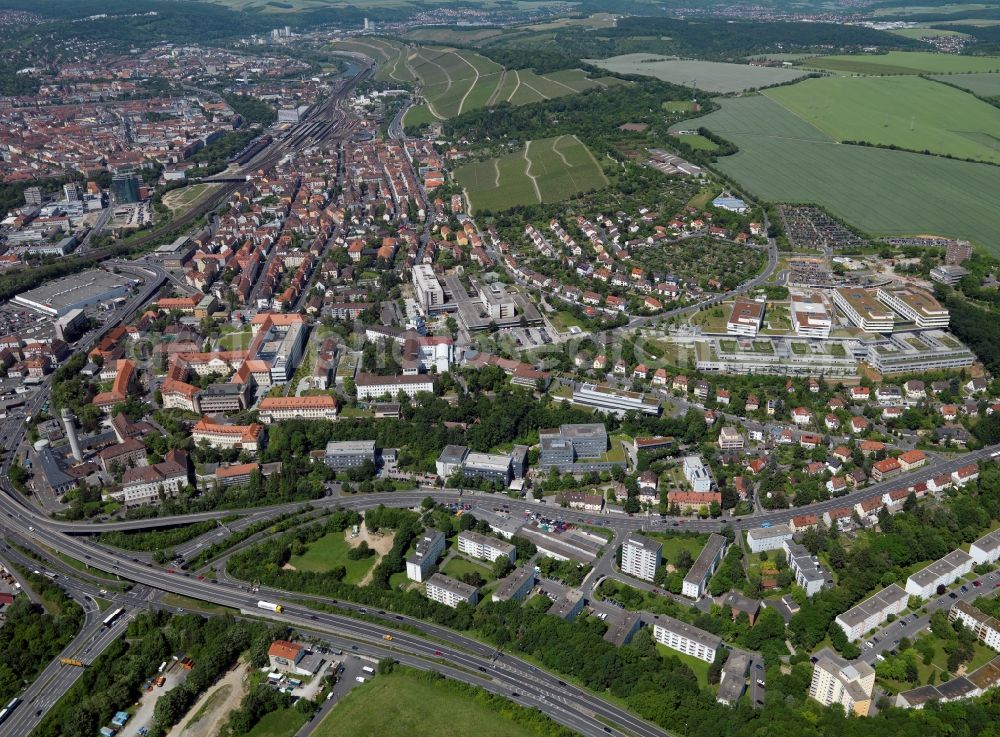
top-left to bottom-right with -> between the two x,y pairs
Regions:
455,136 -> 608,212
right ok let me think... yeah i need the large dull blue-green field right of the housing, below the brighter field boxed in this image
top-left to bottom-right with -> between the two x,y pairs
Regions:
687,95 -> 1000,254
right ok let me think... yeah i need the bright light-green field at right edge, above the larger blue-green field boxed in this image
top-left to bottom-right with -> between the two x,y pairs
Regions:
764,76 -> 1000,163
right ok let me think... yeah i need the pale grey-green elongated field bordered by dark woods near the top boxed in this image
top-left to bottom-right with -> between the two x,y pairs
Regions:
587,54 -> 806,93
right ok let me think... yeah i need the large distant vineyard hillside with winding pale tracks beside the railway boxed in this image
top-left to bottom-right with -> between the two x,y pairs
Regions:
332,38 -> 622,125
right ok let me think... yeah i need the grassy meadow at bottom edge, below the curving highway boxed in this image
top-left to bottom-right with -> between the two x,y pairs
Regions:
313,671 -> 538,737
